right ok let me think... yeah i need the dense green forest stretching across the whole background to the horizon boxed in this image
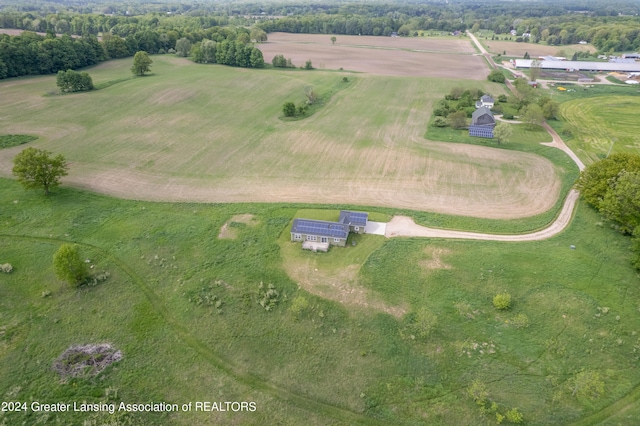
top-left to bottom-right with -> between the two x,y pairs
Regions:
0,0 -> 640,78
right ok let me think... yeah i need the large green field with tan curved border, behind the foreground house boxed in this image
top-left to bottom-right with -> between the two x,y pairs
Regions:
0,55 -> 560,218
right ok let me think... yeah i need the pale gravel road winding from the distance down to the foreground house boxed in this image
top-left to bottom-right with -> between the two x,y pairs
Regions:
385,32 -> 585,241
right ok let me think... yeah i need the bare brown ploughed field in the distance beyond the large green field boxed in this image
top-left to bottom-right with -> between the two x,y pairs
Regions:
258,33 -> 489,80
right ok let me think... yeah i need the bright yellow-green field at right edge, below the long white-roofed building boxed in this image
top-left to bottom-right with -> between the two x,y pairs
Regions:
560,96 -> 640,163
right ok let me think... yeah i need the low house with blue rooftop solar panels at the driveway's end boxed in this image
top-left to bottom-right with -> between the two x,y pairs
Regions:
291,210 -> 369,251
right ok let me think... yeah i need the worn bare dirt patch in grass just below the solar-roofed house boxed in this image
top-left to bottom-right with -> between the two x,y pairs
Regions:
283,254 -> 407,318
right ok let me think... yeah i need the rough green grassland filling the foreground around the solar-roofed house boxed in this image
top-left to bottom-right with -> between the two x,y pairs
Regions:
0,180 -> 640,425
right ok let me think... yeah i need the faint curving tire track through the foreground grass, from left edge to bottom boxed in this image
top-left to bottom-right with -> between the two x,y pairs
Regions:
0,234 -> 382,424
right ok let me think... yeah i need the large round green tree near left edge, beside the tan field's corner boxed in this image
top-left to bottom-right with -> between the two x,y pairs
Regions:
12,148 -> 68,195
